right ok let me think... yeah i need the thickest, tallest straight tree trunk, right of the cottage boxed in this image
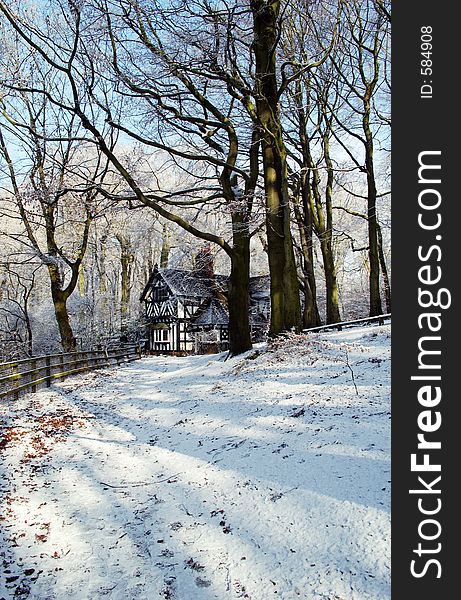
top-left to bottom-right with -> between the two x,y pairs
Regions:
250,0 -> 301,335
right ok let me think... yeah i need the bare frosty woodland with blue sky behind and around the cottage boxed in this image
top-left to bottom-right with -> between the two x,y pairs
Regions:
0,0 -> 391,361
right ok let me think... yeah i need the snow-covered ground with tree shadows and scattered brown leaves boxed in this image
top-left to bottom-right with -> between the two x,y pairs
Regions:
0,326 -> 390,600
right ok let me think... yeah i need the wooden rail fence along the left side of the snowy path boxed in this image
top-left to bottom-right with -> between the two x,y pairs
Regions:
0,345 -> 141,398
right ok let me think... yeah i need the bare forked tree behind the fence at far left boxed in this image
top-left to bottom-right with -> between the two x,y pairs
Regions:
0,79 -> 111,352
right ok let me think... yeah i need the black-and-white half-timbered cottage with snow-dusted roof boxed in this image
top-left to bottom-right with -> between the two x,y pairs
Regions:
141,265 -> 269,353
